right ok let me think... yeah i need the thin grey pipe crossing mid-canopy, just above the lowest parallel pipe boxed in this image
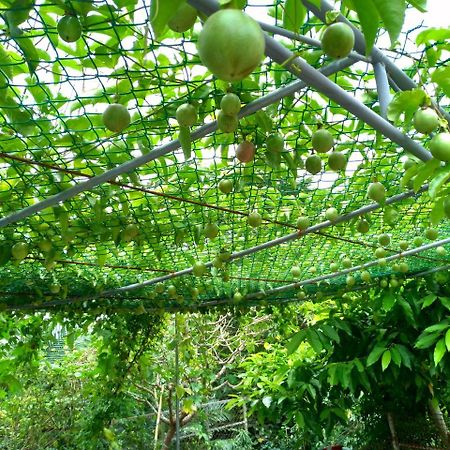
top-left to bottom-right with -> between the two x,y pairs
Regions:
100,185 -> 428,297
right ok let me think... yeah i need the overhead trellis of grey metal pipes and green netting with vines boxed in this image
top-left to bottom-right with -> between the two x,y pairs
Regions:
0,0 -> 450,310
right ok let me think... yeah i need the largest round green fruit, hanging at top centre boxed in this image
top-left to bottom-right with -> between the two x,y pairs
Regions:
197,9 -> 265,81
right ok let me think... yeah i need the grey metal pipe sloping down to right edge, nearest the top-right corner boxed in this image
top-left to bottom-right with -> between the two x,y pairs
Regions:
302,0 -> 450,124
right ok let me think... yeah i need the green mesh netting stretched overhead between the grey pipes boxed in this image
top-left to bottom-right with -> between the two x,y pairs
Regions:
0,0 -> 449,308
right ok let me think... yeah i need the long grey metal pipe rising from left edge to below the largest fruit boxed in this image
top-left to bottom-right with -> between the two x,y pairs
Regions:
0,58 -> 354,228
